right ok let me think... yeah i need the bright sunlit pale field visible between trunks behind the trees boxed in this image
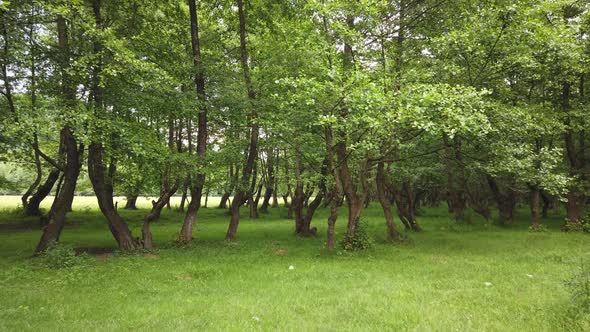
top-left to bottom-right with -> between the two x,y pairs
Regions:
0,195 -> 220,210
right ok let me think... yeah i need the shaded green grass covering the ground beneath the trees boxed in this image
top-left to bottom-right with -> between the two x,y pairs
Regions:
0,196 -> 590,331
